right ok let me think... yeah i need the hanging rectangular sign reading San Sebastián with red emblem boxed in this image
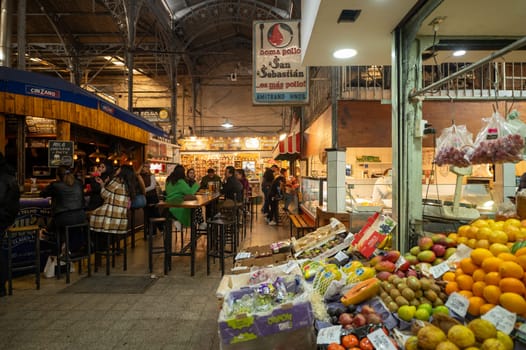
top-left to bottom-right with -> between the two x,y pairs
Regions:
252,21 -> 309,105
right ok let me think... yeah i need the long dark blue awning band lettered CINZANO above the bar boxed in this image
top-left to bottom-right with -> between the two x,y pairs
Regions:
0,67 -> 168,137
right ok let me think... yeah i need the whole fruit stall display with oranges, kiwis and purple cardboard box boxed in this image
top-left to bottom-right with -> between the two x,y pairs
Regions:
217,213 -> 526,350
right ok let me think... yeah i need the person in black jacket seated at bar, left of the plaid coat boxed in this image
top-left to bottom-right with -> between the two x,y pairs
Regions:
40,167 -> 86,251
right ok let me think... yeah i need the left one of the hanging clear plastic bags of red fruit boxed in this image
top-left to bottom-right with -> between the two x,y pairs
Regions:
435,124 -> 473,168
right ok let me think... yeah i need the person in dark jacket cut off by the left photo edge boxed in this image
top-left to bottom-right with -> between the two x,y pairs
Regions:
0,152 -> 20,297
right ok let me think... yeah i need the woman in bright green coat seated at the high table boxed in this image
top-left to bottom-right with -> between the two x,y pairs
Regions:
166,164 -> 199,230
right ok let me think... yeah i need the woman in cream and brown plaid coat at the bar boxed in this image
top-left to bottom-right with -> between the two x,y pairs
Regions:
90,165 -> 137,235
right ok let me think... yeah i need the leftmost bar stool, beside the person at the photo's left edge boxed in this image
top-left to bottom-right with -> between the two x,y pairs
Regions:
6,225 -> 40,295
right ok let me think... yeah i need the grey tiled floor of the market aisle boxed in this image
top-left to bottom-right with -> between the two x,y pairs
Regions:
0,209 -> 289,349
